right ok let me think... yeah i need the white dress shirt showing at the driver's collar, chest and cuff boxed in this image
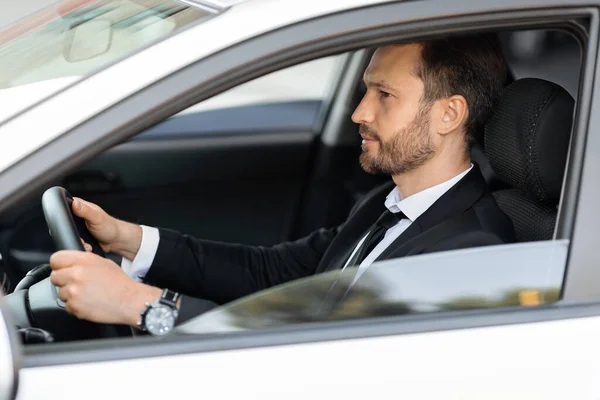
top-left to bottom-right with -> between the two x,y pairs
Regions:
121,164 -> 473,281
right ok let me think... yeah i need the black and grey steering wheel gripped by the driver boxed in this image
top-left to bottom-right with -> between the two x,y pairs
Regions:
5,186 -> 132,341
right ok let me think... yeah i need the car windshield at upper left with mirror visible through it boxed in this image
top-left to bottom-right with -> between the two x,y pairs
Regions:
0,0 -> 212,121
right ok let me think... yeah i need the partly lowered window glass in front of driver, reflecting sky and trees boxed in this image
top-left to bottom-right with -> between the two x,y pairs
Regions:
176,240 -> 568,334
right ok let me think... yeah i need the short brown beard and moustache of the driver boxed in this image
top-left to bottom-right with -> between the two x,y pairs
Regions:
359,106 -> 435,175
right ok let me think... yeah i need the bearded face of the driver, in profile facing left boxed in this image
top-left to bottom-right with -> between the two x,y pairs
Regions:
352,44 -> 435,175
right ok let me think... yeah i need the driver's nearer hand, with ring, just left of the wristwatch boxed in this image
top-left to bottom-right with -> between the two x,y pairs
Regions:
50,250 -> 162,326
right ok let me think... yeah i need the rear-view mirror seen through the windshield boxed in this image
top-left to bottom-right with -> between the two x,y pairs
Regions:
63,19 -> 112,63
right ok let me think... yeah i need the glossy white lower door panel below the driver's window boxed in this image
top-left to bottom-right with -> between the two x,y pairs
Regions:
17,317 -> 600,400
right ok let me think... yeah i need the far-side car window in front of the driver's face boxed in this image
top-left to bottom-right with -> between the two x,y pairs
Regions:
140,54 -> 347,137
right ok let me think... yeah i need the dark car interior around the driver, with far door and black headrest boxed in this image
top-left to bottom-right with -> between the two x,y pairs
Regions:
0,30 -> 581,344
